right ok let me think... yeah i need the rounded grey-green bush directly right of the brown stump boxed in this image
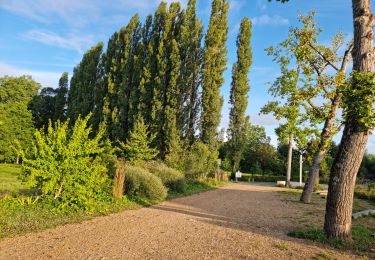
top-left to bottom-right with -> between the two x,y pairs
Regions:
125,165 -> 167,202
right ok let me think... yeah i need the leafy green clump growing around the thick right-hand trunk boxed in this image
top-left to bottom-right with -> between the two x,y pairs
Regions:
343,71 -> 375,131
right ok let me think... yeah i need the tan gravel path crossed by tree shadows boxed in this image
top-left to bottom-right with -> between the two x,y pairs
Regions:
0,184 -> 355,260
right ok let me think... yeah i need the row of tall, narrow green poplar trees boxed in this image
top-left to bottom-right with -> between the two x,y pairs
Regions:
34,0 -> 251,164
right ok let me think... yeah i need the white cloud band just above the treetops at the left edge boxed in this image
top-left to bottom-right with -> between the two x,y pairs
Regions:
0,61 -> 61,87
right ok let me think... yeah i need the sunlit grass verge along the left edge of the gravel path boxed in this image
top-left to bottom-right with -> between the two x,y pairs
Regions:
0,181 -> 224,238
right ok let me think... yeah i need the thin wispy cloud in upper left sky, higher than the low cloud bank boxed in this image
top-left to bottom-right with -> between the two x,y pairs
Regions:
22,30 -> 93,53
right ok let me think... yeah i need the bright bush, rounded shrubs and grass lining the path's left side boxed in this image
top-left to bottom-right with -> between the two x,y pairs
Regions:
0,116 -> 226,237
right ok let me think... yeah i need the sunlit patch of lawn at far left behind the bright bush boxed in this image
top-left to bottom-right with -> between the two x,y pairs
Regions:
0,164 -> 25,195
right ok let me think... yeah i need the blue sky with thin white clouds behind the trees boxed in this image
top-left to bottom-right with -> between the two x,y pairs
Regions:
0,0 -> 375,154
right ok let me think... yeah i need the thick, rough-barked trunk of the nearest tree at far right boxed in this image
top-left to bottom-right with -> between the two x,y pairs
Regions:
324,0 -> 374,240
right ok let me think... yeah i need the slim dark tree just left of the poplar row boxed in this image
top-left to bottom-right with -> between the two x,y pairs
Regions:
53,72 -> 69,121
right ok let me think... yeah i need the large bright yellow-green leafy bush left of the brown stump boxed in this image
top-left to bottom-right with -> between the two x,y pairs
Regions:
22,115 -> 108,210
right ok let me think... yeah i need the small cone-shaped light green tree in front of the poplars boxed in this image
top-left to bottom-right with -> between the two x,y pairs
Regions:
119,118 -> 158,161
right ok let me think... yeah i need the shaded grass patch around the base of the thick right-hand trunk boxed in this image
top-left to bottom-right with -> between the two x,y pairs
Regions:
288,224 -> 375,253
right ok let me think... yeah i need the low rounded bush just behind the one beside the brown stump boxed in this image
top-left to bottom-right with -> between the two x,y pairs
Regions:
142,161 -> 186,193
